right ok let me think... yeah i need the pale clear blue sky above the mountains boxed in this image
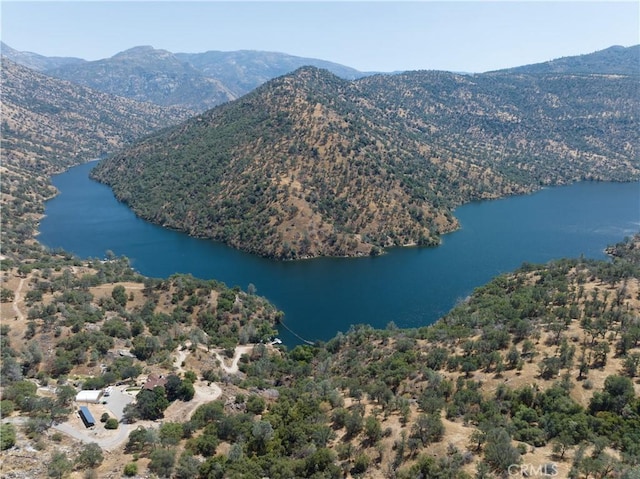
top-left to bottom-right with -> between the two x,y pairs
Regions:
1,0 -> 640,72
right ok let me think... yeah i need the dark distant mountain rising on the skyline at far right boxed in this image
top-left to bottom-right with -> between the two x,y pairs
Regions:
502,45 -> 640,75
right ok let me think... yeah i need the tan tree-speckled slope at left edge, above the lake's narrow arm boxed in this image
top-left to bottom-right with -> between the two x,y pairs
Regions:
2,58 -> 192,173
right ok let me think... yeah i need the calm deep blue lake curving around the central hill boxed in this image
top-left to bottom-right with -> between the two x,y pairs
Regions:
39,163 -> 640,344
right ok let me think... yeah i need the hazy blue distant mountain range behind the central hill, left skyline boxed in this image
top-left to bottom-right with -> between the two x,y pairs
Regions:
3,45 -> 366,111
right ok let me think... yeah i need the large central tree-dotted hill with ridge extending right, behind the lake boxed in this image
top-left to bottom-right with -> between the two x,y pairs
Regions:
94,67 -> 640,258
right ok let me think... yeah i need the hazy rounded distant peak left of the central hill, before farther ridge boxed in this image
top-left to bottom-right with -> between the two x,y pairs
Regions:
47,46 -> 236,111
